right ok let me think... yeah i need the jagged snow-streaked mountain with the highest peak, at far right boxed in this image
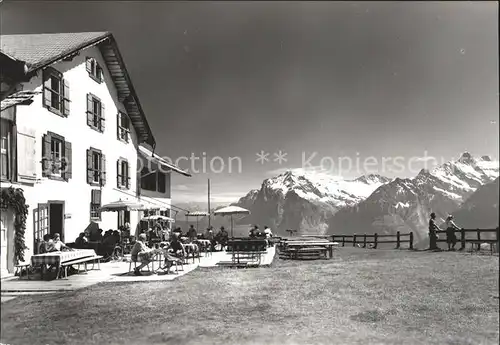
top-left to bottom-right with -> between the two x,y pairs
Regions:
328,152 -> 499,246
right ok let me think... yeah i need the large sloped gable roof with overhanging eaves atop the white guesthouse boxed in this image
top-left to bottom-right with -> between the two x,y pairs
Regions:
0,32 -> 156,147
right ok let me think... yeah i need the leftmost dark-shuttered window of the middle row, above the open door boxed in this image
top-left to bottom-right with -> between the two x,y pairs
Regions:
42,132 -> 73,181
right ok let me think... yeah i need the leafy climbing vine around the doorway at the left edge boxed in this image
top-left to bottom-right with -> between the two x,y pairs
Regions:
0,187 -> 28,264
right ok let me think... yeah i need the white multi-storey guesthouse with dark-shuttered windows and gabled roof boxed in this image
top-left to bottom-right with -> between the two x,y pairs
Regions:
0,32 -> 189,276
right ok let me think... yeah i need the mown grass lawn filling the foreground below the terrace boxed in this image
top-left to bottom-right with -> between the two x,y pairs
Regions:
1,248 -> 499,345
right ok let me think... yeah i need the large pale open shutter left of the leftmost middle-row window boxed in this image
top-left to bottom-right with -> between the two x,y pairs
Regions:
16,128 -> 37,181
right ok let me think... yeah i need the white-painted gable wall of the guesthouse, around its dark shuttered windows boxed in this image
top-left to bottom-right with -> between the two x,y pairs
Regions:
8,47 -> 144,259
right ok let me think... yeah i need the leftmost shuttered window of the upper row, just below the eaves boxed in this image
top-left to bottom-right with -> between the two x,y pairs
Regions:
43,67 -> 70,116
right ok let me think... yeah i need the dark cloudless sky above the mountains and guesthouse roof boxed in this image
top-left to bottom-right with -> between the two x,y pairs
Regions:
0,1 -> 499,202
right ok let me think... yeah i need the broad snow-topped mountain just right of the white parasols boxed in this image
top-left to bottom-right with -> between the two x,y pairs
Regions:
235,170 -> 390,234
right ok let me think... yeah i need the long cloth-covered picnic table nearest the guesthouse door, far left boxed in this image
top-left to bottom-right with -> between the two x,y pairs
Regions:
31,249 -> 98,277
